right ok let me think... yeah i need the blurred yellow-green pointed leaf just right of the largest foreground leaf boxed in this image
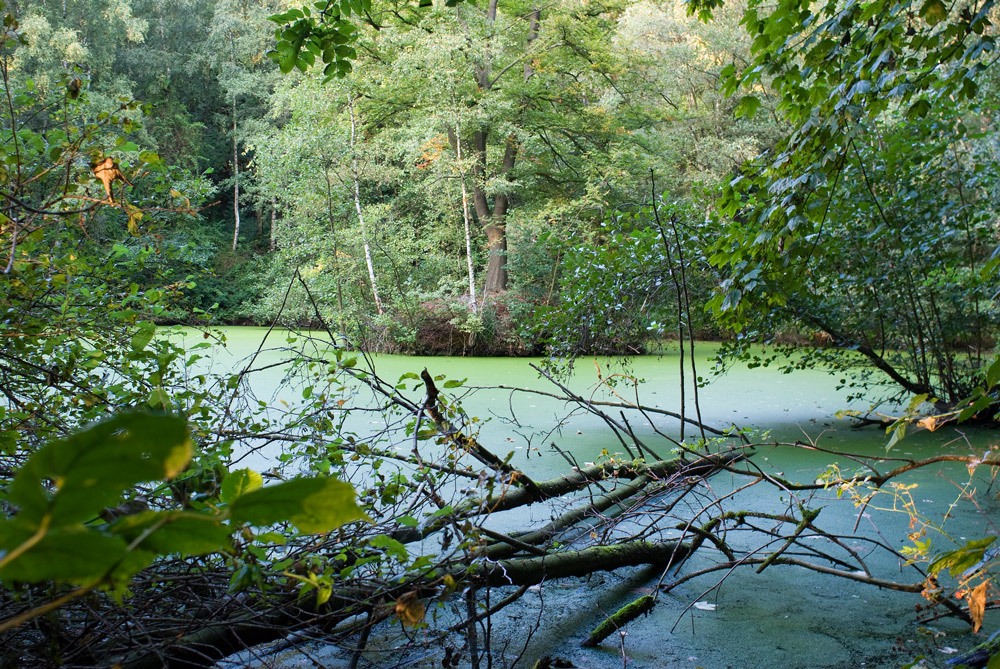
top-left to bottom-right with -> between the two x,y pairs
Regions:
230,478 -> 367,533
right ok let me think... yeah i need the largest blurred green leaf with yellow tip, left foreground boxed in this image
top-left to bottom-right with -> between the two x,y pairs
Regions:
8,413 -> 192,528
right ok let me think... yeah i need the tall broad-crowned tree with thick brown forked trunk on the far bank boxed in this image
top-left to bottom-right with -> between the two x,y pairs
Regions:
276,0 -> 684,295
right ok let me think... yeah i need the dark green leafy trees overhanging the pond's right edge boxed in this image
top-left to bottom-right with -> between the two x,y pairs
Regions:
694,1 -> 997,404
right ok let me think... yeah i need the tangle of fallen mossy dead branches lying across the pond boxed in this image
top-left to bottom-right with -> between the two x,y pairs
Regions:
0,324 -> 1000,669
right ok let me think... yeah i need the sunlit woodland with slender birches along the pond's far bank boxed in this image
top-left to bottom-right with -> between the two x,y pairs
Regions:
11,1 -> 782,354
